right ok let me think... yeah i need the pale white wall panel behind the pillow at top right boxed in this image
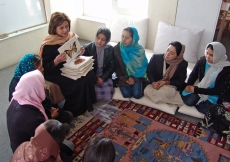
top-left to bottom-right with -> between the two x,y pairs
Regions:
175,0 -> 222,59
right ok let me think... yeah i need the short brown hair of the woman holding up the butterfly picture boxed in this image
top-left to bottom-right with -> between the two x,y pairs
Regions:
48,12 -> 71,35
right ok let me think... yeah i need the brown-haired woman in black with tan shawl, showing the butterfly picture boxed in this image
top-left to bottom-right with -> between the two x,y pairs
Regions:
39,12 -> 96,116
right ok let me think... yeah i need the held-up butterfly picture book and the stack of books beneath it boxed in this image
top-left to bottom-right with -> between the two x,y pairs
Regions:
58,36 -> 94,80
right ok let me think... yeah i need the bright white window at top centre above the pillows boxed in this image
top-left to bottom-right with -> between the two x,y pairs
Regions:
84,0 -> 149,19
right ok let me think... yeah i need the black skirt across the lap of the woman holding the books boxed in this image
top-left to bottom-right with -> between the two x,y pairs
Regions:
45,71 -> 96,116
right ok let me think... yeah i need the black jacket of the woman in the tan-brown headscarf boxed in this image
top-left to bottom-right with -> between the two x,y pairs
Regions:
147,54 -> 188,91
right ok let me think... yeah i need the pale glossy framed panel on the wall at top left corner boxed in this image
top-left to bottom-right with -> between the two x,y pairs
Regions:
0,0 -> 47,35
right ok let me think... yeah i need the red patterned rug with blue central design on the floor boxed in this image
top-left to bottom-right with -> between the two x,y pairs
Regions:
68,100 -> 230,162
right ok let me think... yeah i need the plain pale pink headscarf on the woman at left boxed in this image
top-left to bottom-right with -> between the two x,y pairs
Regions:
13,70 -> 48,120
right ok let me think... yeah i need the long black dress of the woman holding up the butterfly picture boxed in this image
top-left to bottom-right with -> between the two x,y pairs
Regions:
42,45 -> 96,116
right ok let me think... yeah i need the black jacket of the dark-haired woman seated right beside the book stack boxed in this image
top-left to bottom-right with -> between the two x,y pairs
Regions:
83,42 -> 116,82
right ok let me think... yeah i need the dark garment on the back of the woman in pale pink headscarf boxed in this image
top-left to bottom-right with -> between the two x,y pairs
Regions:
6,100 -> 45,152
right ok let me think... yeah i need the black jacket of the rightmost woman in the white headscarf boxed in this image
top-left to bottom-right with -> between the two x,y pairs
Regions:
187,56 -> 230,96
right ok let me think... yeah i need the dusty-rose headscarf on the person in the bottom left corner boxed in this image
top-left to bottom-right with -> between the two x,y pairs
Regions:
11,123 -> 62,162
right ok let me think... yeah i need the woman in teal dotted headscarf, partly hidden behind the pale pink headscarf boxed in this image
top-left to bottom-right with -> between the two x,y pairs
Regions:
9,53 -> 72,123
